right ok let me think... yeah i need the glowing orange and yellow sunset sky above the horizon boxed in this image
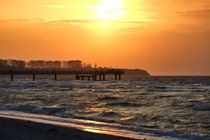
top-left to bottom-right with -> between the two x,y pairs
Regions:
0,0 -> 210,75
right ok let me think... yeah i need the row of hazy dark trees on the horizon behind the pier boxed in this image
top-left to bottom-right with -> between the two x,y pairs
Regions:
0,59 -> 92,69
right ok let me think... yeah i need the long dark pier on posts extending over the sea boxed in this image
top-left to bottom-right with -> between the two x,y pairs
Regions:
0,68 -> 125,81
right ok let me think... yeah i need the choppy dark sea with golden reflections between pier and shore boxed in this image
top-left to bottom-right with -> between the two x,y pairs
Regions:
0,75 -> 210,140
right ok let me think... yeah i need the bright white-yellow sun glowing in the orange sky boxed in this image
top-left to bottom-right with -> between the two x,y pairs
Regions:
96,0 -> 124,20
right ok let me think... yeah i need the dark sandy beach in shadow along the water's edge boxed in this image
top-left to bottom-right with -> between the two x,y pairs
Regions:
0,115 -> 146,140
